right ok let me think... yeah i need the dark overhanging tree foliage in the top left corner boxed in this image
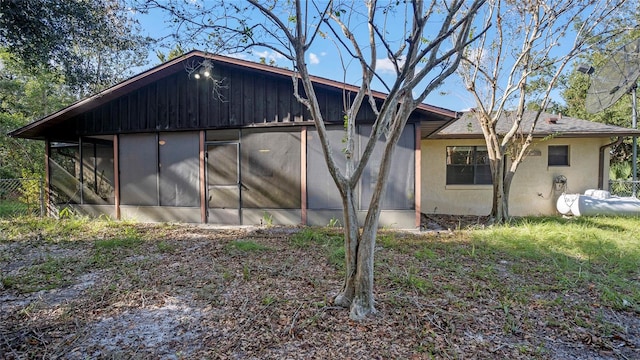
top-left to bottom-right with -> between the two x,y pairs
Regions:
0,0 -> 150,96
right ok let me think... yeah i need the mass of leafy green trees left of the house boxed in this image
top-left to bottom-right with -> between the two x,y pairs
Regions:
0,0 -> 151,177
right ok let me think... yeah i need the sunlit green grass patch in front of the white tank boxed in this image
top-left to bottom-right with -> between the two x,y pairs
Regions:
470,217 -> 640,309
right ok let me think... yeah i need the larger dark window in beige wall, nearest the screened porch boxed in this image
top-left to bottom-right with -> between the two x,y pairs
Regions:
447,146 -> 491,185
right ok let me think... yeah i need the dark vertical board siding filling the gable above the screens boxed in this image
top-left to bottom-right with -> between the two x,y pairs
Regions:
69,59 -> 400,135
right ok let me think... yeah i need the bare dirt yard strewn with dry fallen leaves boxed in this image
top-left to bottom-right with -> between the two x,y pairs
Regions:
0,221 -> 640,359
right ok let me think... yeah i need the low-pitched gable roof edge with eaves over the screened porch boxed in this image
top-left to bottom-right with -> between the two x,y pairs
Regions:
8,50 -> 458,139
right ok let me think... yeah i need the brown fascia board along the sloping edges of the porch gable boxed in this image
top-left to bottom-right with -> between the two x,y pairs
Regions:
8,50 -> 458,137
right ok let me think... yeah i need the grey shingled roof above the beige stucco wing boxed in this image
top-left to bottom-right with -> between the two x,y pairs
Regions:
429,111 -> 640,139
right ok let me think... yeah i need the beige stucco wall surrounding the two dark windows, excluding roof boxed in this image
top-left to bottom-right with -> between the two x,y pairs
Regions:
421,138 -> 610,216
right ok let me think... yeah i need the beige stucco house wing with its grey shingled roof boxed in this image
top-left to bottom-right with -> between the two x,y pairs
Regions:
421,111 -> 640,216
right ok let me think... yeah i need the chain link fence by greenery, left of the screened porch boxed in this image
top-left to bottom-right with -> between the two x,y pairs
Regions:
0,179 -> 45,218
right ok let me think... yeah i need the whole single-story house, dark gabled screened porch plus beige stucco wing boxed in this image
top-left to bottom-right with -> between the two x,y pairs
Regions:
9,51 -> 636,228
